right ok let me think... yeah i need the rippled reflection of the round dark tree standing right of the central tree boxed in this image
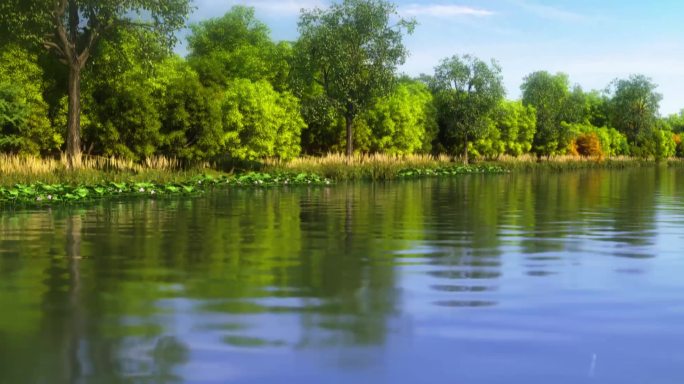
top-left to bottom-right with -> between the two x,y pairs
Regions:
426,176 -> 503,307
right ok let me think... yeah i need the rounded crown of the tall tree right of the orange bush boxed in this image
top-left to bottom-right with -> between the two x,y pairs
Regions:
609,75 -> 662,144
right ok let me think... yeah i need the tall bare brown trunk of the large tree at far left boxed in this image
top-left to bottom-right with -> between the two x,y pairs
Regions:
67,63 -> 81,169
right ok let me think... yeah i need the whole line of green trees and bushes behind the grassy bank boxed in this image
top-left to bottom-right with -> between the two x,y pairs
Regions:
0,0 -> 684,161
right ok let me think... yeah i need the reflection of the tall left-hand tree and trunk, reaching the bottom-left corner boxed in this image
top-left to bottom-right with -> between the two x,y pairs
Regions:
0,211 -> 187,383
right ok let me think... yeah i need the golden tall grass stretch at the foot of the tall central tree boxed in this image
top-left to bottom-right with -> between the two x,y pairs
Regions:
265,154 -> 452,181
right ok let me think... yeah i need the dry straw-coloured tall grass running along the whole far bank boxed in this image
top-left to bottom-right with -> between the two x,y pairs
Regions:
0,154 -> 684,186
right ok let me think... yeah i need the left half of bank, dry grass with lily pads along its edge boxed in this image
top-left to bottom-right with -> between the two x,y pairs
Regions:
0,155 -> 331,206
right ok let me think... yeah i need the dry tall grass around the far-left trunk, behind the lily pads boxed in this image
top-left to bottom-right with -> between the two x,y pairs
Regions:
0,154 -> 210,185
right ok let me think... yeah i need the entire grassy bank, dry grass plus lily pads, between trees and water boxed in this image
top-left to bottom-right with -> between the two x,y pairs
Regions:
0,155 -> 684,206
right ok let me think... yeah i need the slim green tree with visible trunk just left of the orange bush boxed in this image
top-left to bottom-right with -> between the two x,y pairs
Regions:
520,71 -> 570,156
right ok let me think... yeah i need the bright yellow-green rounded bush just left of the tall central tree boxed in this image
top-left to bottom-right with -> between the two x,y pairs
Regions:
220,79 -> 305,160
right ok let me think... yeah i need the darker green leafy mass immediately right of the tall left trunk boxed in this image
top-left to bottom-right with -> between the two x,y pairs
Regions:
78,31 -> 165,160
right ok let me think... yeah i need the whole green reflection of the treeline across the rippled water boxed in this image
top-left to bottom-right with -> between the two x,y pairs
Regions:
0,169 -> 662,383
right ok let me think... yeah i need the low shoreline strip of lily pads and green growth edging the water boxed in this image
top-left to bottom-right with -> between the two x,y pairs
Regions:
0,156 -> 684,209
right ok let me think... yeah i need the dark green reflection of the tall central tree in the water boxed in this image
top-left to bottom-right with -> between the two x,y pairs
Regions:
256,185 -> 405,347
